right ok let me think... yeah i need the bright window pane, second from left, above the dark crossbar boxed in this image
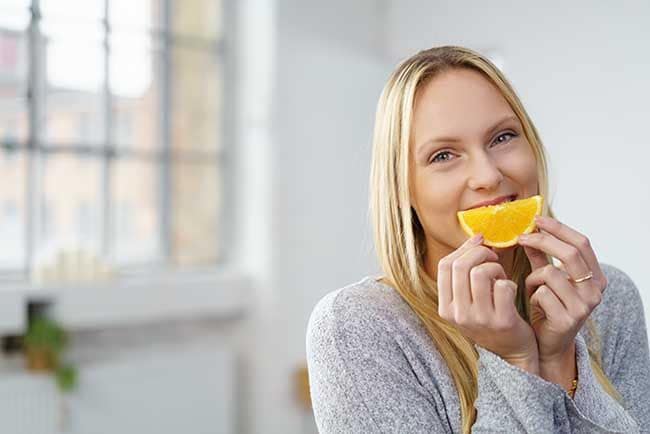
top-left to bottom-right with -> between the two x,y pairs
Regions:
43,33 -> 105,145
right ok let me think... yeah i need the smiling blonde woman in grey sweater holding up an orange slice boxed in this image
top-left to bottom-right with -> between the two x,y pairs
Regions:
307,47 -> 650,433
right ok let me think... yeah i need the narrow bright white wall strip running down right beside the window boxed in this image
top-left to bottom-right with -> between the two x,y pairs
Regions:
232,0 -> 278,433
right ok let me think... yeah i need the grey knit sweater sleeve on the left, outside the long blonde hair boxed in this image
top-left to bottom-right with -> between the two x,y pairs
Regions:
307,293 -> 451,434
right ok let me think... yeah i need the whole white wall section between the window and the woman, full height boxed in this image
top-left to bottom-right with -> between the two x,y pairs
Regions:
237,0 -> 388,434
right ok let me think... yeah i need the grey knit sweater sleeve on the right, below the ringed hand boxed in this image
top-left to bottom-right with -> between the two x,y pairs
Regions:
567,267 -> 650,433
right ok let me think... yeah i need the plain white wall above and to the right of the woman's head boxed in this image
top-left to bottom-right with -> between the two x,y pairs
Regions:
387,0 -> 650,317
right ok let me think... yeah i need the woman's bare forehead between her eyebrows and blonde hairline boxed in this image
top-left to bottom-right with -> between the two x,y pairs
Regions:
413,69 -> 514,141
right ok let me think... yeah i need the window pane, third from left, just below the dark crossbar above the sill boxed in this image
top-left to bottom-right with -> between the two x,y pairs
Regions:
111,159 -> 161,264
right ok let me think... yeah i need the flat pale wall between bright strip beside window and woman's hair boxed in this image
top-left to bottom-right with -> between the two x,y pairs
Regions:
273,0 -> 389,357
